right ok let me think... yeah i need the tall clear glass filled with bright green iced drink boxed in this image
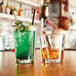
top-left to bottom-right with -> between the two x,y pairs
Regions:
14,26 -> 35,63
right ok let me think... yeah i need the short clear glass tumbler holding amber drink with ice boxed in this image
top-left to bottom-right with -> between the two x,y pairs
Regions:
40,34 -> 64,63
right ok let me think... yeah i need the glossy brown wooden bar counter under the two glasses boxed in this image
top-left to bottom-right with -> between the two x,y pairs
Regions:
0,50 -> 76,76
